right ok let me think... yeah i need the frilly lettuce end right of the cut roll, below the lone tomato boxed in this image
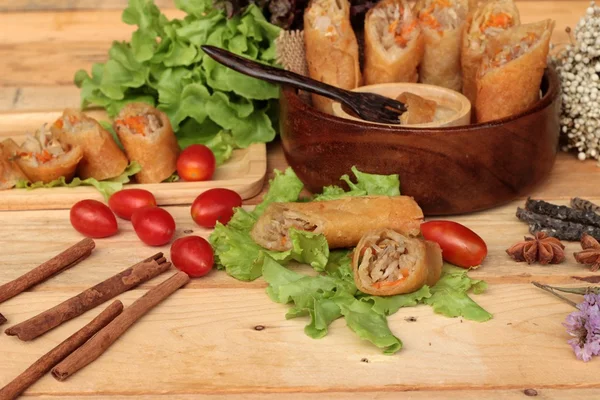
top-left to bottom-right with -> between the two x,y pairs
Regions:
424,264 -> 492,322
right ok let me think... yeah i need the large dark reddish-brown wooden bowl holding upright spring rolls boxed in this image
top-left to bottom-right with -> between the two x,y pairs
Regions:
280,68 -> 560,215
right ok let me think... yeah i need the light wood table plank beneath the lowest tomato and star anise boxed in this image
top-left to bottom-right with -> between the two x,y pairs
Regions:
0,200 -> 596,291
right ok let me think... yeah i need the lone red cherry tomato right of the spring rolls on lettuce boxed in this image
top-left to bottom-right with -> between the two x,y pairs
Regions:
421,221 -> 487,268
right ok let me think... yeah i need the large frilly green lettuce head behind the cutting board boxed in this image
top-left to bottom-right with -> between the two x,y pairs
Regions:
75,0 -> 281,150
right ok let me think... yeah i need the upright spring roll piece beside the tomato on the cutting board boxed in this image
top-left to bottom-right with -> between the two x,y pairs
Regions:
114,103 -> 179,183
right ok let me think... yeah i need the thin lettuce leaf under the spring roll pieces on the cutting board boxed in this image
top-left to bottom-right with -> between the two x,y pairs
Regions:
15,161 -> 142,201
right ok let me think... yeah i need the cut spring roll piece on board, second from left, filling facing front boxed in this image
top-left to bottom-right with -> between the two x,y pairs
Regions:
10,125 -> 83,183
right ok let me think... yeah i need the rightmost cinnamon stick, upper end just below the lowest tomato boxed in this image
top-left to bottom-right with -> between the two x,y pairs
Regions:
52,271 -> 190,381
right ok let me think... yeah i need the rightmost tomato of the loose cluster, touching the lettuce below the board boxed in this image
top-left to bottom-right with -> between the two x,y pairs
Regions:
192,189 -> 242,228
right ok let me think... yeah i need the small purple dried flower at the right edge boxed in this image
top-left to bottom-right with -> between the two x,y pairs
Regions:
563,294 -> 600,362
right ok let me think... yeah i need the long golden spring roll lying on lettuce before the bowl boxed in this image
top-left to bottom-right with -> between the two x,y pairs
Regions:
251,196 -> 423,251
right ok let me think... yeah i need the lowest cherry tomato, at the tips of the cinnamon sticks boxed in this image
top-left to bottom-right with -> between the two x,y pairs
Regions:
171,236 -> 215,278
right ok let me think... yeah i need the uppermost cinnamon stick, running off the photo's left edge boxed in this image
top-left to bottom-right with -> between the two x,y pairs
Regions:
0,238 -> 96,303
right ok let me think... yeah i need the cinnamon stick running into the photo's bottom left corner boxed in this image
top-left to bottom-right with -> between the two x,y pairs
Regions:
0,300 -> 123,400
